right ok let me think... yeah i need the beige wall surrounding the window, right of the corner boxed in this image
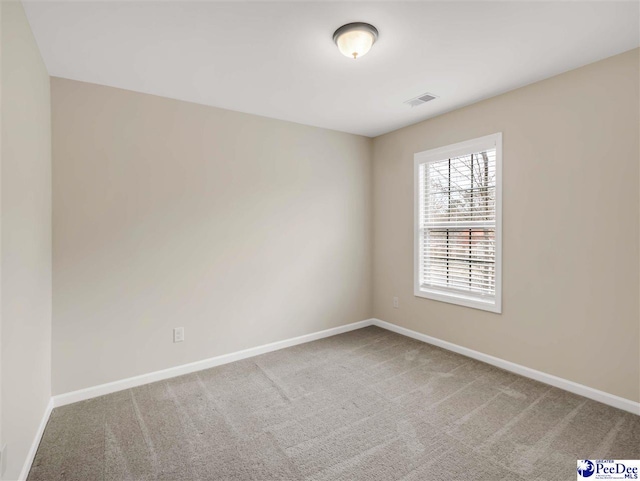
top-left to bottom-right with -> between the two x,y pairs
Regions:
373,50 -> 640,401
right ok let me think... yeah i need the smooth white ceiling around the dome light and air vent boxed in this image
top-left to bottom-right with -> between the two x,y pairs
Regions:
23,1 -> 640,136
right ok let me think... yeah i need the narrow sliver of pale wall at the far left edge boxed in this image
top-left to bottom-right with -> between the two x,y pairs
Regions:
0,2 -> 51,479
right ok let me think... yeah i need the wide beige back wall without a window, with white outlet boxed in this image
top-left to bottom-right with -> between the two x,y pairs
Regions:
51,78 -> 371,394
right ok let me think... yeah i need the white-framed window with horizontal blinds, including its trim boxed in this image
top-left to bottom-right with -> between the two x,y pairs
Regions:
414,133 -> 502,313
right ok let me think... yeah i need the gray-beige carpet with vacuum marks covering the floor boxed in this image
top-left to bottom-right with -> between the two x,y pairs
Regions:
28,327 -> 640,481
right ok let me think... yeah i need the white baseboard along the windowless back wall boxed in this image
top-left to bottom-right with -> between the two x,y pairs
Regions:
52,319 -> 373,407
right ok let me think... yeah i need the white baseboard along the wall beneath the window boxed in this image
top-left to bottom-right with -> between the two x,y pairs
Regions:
373,319 -> 640,415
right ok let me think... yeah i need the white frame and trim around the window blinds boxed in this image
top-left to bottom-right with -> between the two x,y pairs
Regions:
413,132 -> 502,314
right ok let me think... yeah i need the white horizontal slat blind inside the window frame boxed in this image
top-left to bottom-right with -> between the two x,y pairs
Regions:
419,148 -> 496,297
